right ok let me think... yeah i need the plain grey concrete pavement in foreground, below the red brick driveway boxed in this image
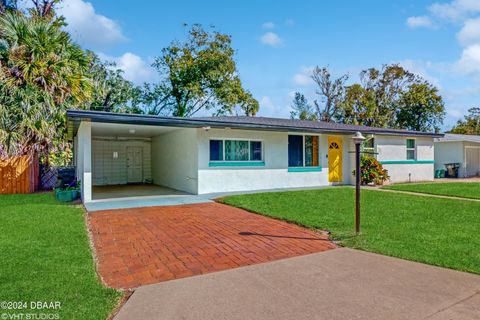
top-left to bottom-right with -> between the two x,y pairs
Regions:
115,248 -> 480,320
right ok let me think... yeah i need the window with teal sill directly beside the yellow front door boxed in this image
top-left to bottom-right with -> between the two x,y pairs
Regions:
288,135 -> 320,167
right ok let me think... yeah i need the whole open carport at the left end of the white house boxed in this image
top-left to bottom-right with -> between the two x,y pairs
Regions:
69,112 -> 197,203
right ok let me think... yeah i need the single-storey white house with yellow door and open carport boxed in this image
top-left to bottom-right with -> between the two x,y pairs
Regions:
67,110 -> 442,202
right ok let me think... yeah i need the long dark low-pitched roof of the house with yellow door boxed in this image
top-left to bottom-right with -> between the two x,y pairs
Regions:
67,110 -> 443,138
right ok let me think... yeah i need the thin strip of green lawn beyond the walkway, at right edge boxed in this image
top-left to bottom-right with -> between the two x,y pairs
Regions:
383,182 -> 480,199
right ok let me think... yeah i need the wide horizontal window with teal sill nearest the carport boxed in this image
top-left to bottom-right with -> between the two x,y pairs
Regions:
210,139 -> 263,161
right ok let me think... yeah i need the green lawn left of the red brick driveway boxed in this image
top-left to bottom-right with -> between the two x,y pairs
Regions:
0,193 -> 121,319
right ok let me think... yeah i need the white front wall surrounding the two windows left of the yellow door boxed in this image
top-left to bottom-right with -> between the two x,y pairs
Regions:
194,129 -> 338,193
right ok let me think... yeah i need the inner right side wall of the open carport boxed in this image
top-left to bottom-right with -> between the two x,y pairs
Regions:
151,128 -> 198,193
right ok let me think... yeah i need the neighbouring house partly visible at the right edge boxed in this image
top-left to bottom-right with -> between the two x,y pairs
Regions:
435,133 -> 480,177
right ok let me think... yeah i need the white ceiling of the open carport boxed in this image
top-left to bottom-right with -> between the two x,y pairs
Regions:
92,122 -> 179,138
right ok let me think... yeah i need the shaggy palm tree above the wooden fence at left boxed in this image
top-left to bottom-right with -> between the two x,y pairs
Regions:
0,12 -> 92,157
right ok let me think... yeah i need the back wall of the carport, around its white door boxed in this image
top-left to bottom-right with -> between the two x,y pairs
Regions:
92,137 -> 152,186
